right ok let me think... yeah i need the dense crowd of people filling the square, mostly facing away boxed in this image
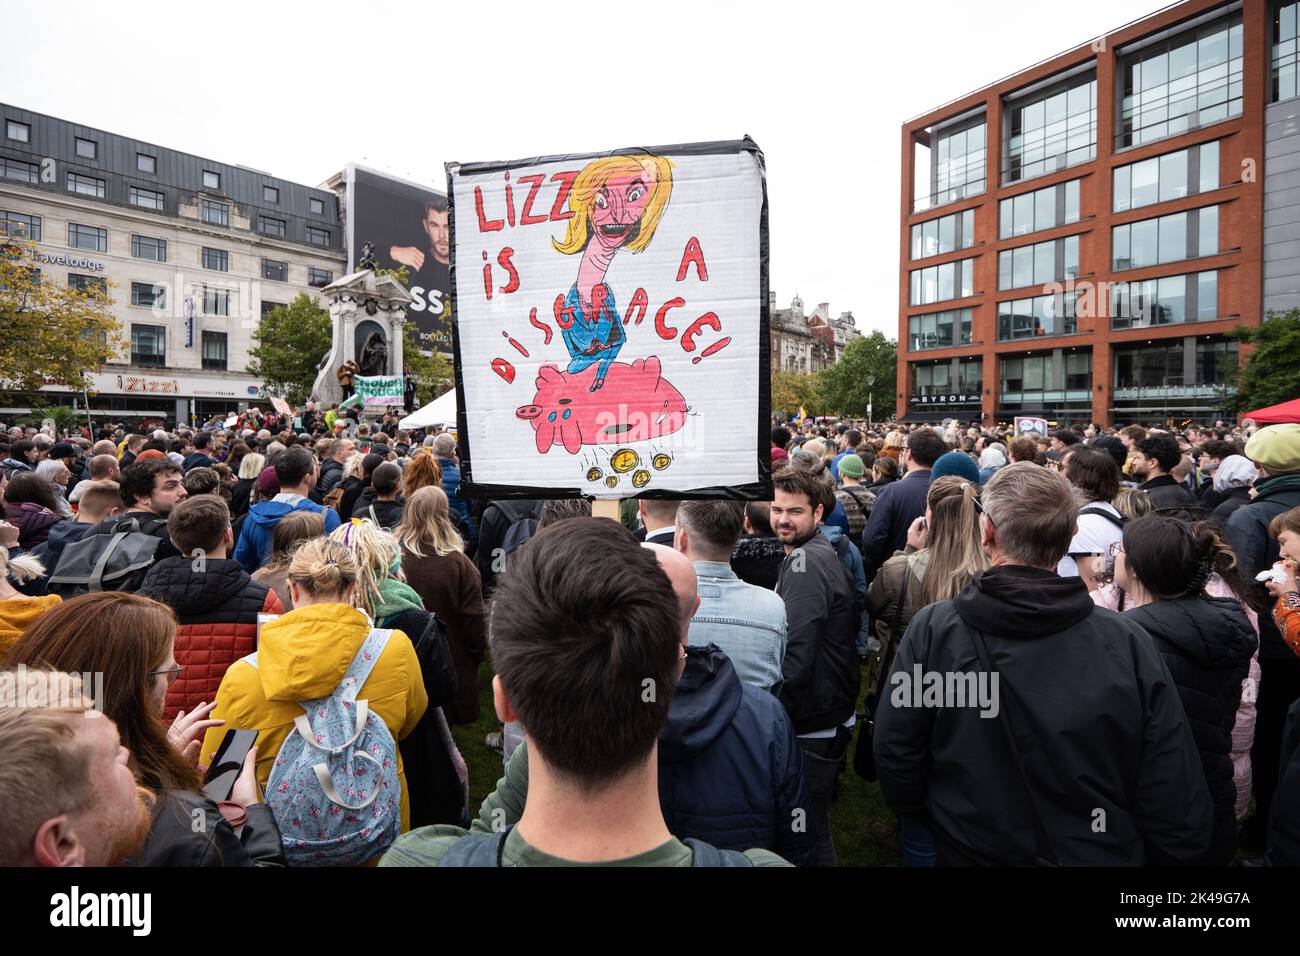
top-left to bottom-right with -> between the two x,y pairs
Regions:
0,403 -> 1300,866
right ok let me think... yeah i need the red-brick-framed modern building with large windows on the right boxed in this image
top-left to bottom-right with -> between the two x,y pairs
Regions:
897,0 -> 1300,424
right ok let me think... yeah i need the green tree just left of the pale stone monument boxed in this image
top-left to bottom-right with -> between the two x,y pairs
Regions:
248,293 -> 334,406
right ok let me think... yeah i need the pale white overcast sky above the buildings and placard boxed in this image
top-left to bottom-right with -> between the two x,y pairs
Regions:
0,0 -> 1157,337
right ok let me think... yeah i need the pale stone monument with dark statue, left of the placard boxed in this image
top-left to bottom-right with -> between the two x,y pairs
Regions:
312,269 -> 411,408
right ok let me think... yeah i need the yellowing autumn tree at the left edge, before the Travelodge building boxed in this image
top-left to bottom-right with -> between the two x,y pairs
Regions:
0,235 -> 124,403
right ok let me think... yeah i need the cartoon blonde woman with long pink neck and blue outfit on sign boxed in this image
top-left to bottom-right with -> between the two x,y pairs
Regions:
551,153 -> 672,392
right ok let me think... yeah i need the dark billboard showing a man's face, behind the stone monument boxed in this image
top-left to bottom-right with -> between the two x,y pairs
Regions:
347,165 -> 451,351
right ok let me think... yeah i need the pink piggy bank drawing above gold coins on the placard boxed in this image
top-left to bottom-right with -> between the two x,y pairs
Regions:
515,355 -> 690,455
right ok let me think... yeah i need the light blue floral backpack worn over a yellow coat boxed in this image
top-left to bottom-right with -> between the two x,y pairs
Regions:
243,628 -> 402,866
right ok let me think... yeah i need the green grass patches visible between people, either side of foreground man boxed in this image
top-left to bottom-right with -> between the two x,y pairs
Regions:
451,659 -> 902,866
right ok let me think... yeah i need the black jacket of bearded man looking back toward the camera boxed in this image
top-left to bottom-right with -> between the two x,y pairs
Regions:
776,532 -> 862,734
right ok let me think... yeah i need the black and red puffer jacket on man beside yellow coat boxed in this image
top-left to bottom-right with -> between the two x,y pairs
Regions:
139,557 -> 285,721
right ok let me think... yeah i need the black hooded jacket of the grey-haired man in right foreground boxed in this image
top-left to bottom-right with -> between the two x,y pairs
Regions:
874,566 -> 1214,865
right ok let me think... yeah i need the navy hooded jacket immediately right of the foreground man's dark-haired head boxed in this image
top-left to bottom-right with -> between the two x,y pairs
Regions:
659,644 -> 816,866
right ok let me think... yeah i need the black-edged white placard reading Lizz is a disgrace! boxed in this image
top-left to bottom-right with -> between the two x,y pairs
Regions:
447,138 -> 771,499
